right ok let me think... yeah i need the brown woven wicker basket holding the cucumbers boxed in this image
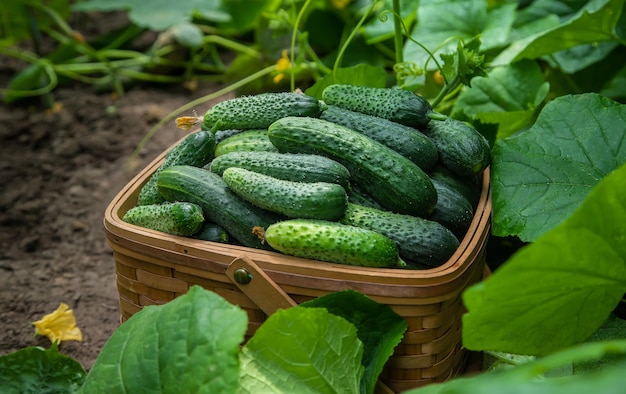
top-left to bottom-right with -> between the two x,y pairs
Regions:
104,140 -> 491,393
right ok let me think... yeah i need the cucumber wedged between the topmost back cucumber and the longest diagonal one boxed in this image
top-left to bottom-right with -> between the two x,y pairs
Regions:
320,105 -> 438,171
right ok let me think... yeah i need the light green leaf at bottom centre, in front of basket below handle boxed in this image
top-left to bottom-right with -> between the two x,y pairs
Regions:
239,307 -> 363,394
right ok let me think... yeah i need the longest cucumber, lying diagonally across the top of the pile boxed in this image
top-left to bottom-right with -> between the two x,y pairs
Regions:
268,117 -> 437,216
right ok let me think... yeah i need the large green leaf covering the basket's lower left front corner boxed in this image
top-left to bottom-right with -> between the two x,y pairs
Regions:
81,286 -> 248,393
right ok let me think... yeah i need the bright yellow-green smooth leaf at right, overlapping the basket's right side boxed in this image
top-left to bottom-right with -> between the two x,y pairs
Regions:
463,162 -> 626,355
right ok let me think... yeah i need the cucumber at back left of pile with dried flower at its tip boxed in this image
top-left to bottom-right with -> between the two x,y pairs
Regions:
203,92 -> 323,131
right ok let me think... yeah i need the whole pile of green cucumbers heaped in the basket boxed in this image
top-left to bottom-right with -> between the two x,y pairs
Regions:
123,84 -> 491,269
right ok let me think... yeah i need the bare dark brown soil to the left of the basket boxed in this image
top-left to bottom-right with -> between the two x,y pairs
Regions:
0,63 -> 229,370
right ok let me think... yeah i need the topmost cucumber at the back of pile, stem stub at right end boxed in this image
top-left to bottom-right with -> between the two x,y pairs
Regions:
322,84 -> 439,128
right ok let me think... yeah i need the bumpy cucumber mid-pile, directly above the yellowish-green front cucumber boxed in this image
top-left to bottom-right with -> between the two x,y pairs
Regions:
222,167 -> 348,220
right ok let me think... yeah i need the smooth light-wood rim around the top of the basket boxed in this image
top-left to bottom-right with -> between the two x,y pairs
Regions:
103,137 -> 491,286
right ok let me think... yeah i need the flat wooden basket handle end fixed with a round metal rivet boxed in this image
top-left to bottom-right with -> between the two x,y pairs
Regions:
226,256 -> 298,316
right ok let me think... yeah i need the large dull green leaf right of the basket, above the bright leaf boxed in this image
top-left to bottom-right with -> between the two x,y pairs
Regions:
492,93 -> 626,241
